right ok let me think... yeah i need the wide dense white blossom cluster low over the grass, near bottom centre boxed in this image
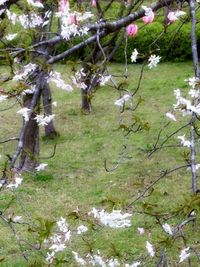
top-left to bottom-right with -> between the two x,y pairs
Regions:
89,208 -> 132,228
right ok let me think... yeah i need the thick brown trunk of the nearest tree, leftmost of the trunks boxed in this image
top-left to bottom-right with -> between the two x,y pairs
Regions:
19,95 -> 40,171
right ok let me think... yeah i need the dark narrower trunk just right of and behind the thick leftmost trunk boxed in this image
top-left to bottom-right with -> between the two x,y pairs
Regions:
42,82 -> 58,139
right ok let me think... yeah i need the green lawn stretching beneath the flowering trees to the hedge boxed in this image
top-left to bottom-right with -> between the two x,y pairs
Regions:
0,62 -> 199,267
